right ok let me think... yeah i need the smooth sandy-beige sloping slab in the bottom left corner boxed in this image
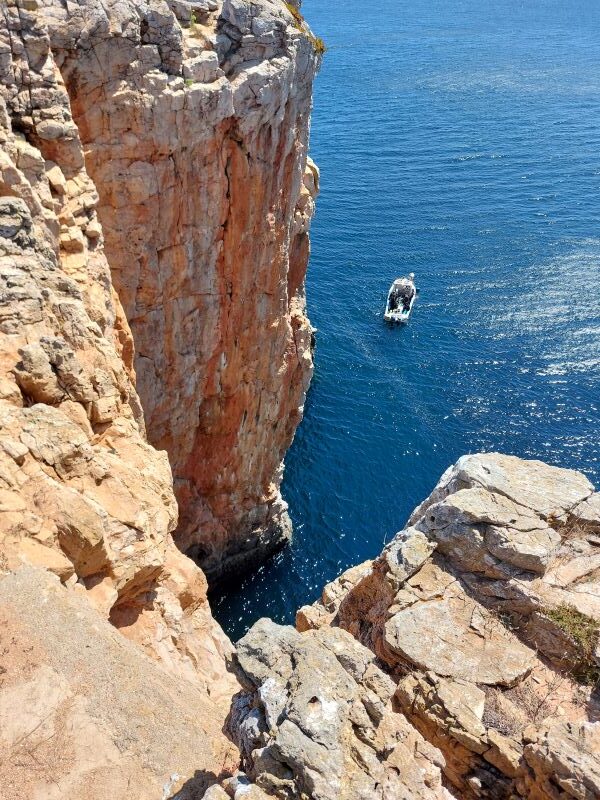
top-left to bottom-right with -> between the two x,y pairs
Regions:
0,567 -> 238,800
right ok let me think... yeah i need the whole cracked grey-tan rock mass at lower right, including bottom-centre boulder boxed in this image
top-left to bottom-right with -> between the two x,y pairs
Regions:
193,454 -> 600,800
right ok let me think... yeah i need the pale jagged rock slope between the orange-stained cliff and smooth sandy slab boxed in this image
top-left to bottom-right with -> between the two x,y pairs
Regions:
0,0 -> 235,696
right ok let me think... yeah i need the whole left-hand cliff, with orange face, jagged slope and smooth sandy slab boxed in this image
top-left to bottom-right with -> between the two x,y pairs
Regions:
0,0 -> 318,800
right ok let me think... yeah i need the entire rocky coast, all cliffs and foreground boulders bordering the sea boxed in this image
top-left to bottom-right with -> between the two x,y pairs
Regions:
0,0 -> 600,800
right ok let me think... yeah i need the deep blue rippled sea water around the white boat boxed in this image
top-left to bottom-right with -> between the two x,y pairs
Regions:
213,0 -> 600,639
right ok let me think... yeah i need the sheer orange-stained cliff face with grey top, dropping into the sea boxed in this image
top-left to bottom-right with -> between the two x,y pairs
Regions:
45,0 -> 318,578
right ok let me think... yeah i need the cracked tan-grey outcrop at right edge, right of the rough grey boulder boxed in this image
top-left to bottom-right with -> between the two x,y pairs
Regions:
297,454 -> 600,800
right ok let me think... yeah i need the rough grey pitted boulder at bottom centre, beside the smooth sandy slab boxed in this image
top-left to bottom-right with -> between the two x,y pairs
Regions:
232,620 -> 444,800
